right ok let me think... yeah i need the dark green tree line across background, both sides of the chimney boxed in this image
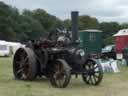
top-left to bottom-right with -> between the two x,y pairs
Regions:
0,1 -> 128,45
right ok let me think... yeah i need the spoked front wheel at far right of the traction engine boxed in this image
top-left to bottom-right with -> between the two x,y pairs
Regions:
82,59 -> 103,85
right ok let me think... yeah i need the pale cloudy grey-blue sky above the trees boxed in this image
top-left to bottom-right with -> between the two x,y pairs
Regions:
0,0 -> 128,23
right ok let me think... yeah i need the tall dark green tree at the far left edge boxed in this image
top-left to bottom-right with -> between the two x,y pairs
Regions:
0,2 -> 16,40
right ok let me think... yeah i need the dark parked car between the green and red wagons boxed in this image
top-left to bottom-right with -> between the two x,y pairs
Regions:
102,44 -> 116,59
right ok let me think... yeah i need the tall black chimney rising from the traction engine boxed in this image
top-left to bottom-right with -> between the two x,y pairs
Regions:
71,11 -> 79,43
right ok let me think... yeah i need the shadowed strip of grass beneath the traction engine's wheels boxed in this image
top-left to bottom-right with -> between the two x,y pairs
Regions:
6,77 -> 103,91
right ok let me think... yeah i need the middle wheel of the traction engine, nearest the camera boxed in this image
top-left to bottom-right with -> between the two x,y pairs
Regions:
50,59 -> 71,88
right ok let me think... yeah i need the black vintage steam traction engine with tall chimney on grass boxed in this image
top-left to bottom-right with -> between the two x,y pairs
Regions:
13,12 -> 103,88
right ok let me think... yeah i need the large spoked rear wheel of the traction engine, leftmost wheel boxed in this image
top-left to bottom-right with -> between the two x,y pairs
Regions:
13,48 -> 36,80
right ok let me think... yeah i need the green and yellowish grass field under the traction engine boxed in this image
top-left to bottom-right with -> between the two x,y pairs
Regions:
0,58 -> 128,96
